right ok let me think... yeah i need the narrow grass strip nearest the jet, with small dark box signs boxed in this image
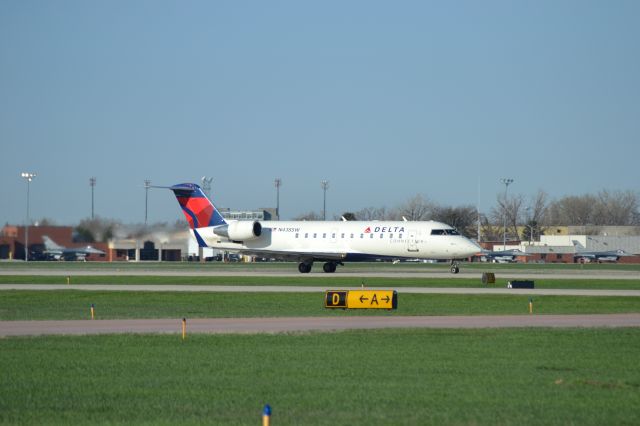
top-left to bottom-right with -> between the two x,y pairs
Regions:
0,275 -> 640,290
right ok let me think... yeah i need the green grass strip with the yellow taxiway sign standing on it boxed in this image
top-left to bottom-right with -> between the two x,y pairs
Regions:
0,290 -> 640,321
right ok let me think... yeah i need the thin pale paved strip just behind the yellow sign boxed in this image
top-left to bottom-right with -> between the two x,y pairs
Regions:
0,284 -> 640,297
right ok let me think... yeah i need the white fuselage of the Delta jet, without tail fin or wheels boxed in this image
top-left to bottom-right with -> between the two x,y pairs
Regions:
192,221 -> 481,261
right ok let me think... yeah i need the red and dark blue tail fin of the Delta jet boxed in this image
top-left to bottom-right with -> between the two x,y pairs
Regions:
169,183 -> 227,229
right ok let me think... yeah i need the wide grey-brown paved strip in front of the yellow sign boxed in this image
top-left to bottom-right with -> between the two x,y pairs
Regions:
0,314 -> 640,337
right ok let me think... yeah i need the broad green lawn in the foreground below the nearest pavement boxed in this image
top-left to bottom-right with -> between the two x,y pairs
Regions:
0,329 -> 640,425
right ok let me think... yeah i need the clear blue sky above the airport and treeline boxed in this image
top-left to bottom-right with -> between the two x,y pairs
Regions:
0,0 -> 640,224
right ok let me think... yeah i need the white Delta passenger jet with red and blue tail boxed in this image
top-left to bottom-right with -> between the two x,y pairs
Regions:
163,183 -> 481,274
